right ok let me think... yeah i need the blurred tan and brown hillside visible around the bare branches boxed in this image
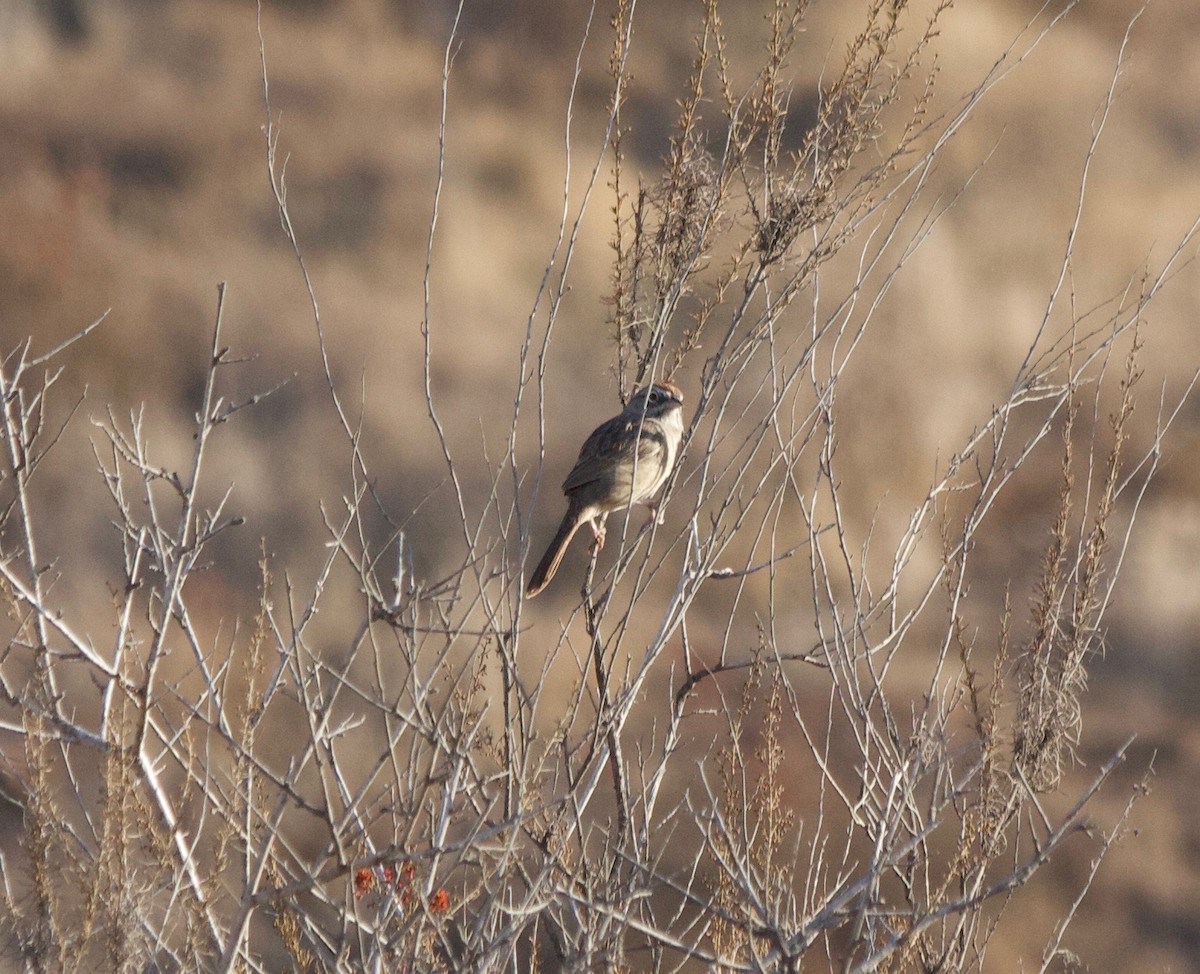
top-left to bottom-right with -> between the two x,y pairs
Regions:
0,0 -> 1200,972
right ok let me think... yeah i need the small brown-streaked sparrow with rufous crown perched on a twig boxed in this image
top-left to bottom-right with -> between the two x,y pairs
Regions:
526,383 -> 683,596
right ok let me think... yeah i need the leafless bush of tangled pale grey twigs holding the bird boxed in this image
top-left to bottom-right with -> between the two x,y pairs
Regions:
0,0 -> 1190,972
